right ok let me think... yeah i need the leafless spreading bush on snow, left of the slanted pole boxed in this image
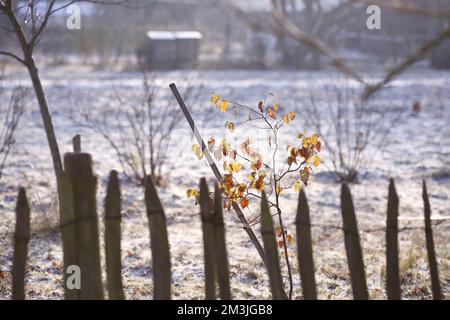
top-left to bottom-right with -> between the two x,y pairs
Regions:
71,72 -> 202,185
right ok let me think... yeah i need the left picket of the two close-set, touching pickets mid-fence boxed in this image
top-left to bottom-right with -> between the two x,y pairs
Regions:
200,178 -> 217,300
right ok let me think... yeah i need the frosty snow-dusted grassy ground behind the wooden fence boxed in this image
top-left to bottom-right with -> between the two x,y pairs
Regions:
0,67 -> 450,299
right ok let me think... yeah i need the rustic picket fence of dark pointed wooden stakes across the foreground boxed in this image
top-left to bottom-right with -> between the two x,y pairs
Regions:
12,152 -> 442,300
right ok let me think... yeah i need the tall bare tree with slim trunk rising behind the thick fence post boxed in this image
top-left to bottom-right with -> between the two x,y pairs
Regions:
0,0 -> 155,180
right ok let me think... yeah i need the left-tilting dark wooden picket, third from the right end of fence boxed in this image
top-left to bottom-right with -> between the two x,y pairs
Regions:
341,183 -> 369,300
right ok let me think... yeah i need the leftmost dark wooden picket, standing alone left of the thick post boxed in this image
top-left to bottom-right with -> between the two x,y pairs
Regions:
12,188 -> 30,300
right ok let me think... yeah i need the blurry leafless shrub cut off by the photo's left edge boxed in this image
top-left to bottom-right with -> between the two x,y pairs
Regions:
0,65 -> 29,179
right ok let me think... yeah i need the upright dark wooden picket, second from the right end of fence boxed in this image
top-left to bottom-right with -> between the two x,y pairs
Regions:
386,179 -> 401,300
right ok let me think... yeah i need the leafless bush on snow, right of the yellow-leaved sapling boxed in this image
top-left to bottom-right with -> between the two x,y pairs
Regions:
297,79 -> 404,182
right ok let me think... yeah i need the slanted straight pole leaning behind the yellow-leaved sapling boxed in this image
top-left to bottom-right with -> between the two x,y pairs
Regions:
169,83 -> 267,269
